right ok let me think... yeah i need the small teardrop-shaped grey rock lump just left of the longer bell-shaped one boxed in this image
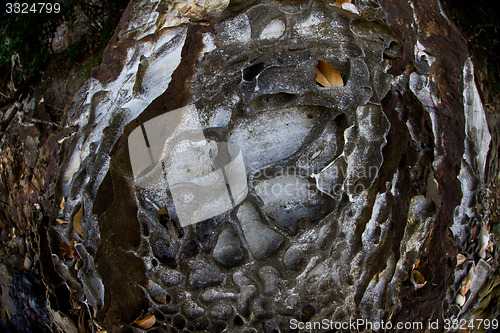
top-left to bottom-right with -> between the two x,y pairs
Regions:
213,226 -> 243,267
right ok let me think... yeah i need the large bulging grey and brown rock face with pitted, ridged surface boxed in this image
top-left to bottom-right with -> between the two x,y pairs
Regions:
38,0 -> 494,332
